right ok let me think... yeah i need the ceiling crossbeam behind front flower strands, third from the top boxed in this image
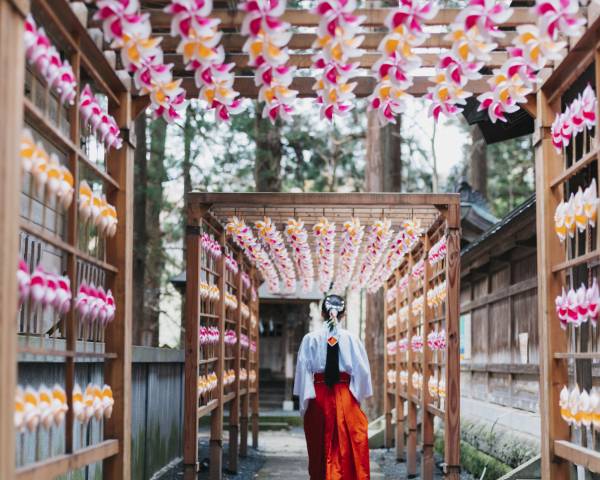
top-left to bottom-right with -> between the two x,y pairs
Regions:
165,52 -> 508,71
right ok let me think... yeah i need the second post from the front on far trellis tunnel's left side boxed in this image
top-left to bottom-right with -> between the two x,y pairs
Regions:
210,232 -> 226,480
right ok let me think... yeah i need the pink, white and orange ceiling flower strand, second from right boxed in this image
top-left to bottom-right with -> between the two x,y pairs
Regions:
426,0 -> 512,121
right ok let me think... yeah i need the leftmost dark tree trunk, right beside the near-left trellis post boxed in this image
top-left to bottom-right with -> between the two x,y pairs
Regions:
133,113 -> 148,345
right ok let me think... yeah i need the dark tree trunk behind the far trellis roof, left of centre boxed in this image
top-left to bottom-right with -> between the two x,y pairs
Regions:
254,108 -> 282,192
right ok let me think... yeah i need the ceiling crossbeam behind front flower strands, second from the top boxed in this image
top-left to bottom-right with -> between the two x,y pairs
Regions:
159,32 -> 516,53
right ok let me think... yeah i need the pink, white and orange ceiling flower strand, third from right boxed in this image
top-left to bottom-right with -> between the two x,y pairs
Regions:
369,0 -> 438,125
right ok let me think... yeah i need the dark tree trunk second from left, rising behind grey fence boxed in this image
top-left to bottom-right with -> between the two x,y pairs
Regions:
142,119 -> 167,346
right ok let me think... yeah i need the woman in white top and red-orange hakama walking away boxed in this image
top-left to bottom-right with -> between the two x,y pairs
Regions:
294,295 -> 373,480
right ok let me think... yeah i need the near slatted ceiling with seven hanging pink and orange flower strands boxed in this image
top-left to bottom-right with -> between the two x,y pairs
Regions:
72,0 -> 585,125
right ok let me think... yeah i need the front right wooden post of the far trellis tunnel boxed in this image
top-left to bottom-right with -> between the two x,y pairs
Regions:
444,204 -> 460,480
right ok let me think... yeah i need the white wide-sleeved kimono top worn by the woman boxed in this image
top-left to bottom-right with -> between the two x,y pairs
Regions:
294,325 -> 373,415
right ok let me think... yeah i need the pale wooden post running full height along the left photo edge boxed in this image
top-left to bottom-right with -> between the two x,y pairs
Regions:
0,0 -> 29,479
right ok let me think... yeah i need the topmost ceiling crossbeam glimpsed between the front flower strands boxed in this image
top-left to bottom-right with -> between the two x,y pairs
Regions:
144,7 -> 536,31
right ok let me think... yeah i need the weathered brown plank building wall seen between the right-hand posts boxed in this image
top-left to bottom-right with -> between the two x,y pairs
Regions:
461,201 -> 539,412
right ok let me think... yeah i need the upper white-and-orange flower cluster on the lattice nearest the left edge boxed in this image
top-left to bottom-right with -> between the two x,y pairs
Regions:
19,129 -> 74,210
